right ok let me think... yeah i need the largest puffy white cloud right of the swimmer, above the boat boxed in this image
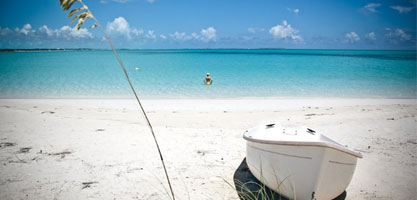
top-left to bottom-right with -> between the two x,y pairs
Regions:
269,20 -> 303,42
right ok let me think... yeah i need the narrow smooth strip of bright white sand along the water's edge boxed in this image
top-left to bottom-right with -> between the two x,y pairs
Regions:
0,98 -> 417,110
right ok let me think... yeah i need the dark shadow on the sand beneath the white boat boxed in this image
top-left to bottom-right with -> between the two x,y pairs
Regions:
233,158 -> 346,200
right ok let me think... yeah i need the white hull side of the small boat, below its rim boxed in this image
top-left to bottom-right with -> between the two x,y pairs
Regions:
246,141 -> 357,200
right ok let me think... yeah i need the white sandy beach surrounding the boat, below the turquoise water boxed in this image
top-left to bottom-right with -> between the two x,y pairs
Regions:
0,99 -> 417,200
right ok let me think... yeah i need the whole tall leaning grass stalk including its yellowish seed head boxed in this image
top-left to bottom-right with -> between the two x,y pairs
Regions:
59,0 -> 175,200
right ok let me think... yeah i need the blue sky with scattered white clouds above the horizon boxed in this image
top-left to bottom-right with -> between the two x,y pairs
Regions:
0,0 -> 416,50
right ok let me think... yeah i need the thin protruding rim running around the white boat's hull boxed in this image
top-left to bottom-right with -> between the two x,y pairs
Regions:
243,134 -> 363,158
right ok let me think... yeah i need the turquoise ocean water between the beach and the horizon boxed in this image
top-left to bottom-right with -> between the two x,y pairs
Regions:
0,49 -> 417,98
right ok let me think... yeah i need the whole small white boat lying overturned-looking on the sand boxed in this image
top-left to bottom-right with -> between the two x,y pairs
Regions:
243,124 -> 362,200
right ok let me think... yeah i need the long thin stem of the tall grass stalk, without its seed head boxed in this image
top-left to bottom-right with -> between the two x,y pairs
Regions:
80,0 -> 175,200
